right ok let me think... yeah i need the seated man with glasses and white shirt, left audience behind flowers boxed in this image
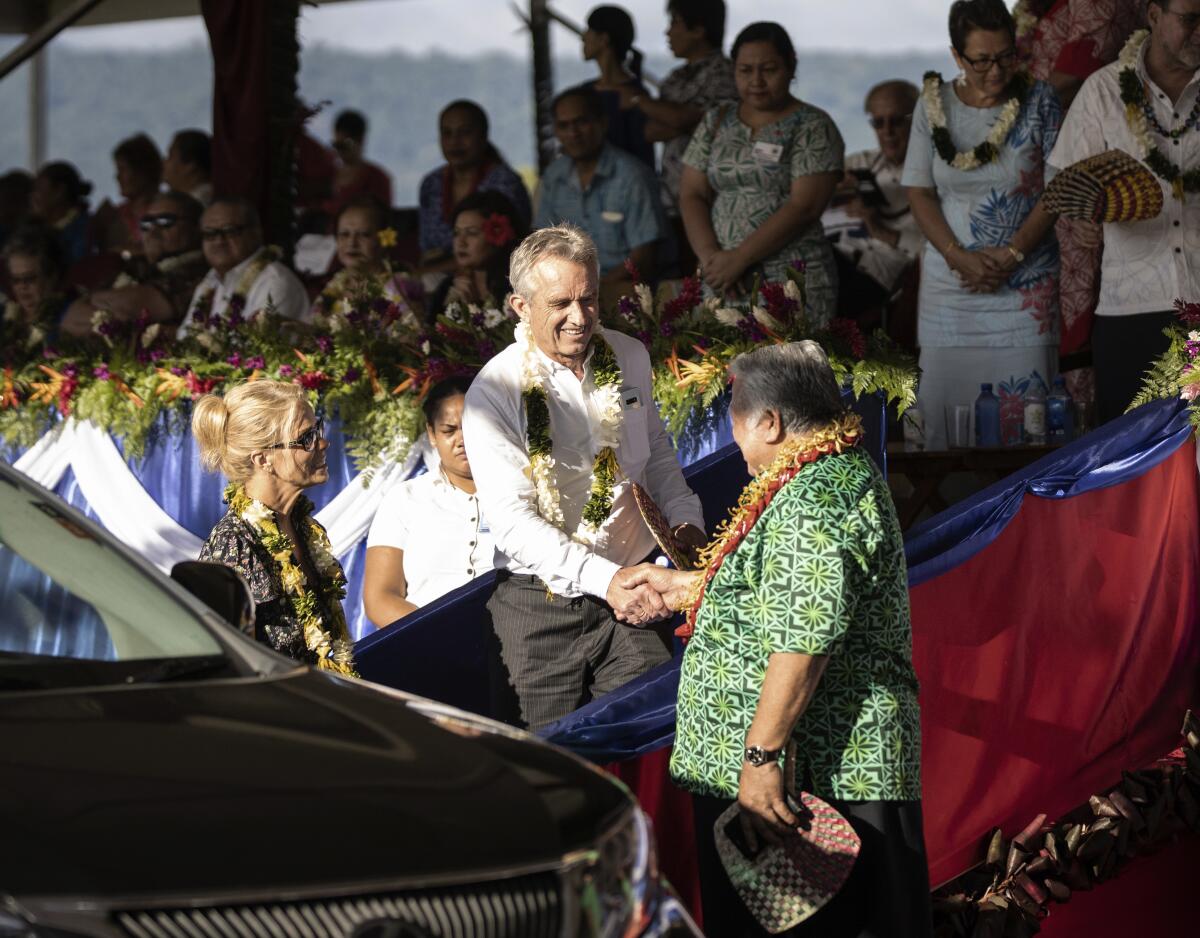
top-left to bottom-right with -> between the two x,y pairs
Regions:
179,198 -> 308,338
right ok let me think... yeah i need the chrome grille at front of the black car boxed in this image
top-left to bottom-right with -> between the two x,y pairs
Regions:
115,873 -> 563,938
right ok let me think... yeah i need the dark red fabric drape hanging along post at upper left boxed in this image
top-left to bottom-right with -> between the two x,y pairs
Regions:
200,0 -> 271,221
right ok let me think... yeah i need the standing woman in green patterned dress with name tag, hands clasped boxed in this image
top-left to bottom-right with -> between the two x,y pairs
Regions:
679,23 -> 844,324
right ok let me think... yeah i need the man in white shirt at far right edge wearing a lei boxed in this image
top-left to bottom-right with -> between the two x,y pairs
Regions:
1050,0 -> 1200,422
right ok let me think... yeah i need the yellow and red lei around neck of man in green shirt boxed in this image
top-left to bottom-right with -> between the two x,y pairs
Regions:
676,414 -> 863,641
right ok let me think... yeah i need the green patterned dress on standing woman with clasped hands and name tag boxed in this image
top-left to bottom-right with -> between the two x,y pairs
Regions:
683,102 -> 845,324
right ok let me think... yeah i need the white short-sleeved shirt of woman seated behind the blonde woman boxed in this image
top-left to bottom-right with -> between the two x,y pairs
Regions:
367,467 -> 496,606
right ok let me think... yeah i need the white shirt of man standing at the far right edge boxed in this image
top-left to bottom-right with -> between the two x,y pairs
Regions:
1050,44 -> 1200,315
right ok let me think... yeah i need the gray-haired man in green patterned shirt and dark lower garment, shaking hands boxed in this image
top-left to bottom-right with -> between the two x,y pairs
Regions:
632,342 -> 931,938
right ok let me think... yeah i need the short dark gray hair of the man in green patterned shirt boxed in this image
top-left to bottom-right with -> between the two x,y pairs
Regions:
730,339 -> 846,433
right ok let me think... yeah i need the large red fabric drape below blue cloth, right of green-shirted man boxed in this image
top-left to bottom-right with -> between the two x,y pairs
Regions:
910,440 -> 1200,884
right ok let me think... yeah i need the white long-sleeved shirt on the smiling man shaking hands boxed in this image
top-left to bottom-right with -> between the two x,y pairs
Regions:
463,330 -> 704,599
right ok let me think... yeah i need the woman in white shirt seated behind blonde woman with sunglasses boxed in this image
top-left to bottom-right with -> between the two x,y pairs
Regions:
362,377 -> 494,627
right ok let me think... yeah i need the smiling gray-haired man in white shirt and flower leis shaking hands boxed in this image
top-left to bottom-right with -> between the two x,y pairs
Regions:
463,226 -> 704,727
